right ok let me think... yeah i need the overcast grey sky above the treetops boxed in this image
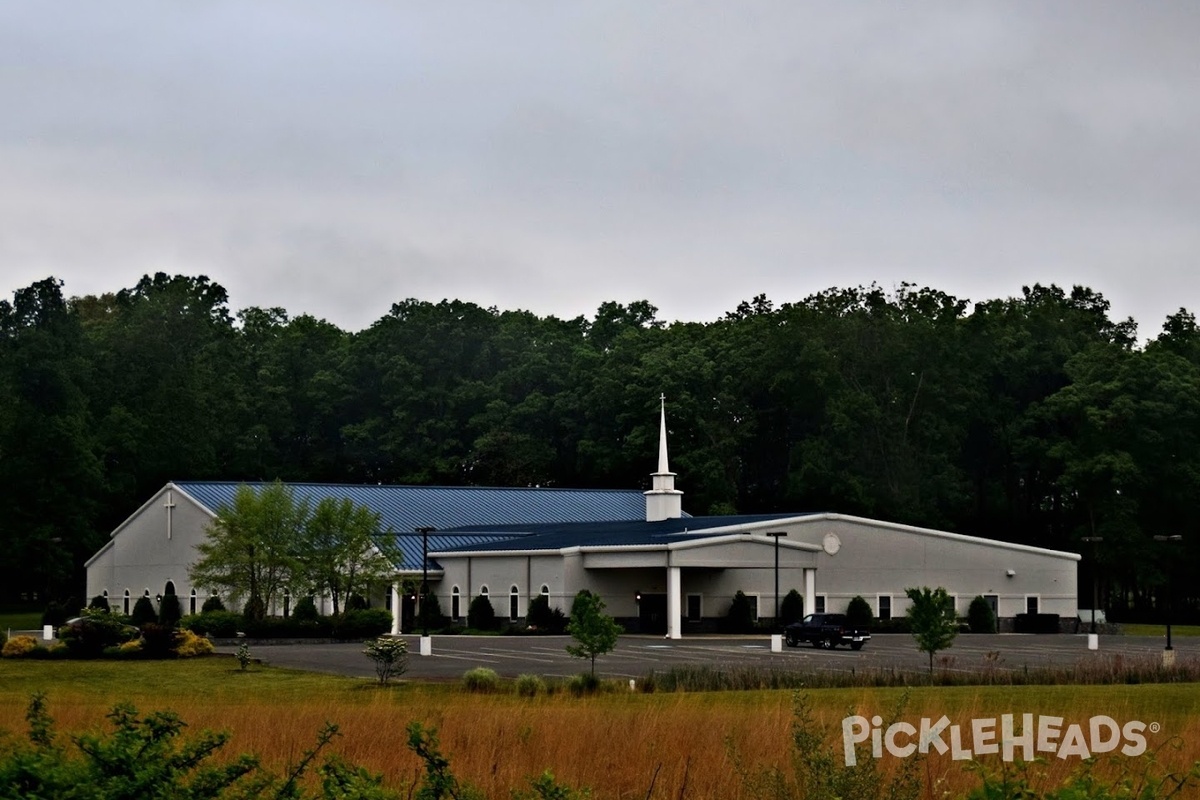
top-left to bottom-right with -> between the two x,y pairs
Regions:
0,0 -> 1200,337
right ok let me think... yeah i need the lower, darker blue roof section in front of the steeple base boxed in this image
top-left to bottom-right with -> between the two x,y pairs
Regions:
430,513 -> 808,553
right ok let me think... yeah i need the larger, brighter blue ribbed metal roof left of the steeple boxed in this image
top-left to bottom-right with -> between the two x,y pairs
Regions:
174,481 -> 672,570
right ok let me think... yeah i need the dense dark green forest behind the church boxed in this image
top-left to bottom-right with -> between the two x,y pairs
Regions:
0,273 -> 1200,620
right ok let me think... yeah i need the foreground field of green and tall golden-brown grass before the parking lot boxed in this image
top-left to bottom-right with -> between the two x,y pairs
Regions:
0,657 -> 1200,798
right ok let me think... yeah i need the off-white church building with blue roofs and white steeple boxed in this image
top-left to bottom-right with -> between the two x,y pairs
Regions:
86,411 -> 1080,638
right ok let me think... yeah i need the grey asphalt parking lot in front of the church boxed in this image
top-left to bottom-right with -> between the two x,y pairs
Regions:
220,633 -> 1200,680
